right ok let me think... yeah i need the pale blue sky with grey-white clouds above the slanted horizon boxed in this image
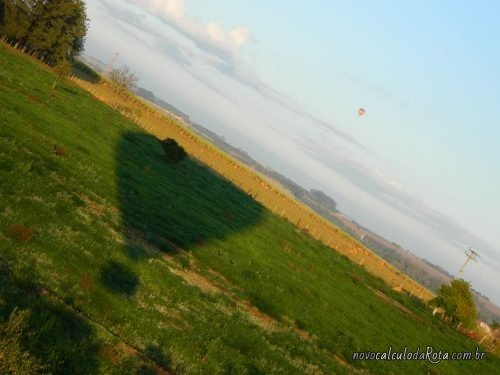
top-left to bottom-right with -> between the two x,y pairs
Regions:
85,0 -> 500,303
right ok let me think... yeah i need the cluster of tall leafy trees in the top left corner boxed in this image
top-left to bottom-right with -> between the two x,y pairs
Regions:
0,0 -> 87,66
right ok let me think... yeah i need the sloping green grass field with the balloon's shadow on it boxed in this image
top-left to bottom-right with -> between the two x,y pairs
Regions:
0,42 -> 500,374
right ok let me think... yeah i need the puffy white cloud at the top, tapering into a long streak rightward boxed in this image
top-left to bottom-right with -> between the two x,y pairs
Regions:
95,0 -> 372,153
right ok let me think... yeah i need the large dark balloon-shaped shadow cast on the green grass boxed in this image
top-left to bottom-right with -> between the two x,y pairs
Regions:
117,132 -> 263,260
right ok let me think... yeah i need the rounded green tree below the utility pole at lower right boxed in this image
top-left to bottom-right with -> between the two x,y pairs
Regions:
431,279 -> 477,329
